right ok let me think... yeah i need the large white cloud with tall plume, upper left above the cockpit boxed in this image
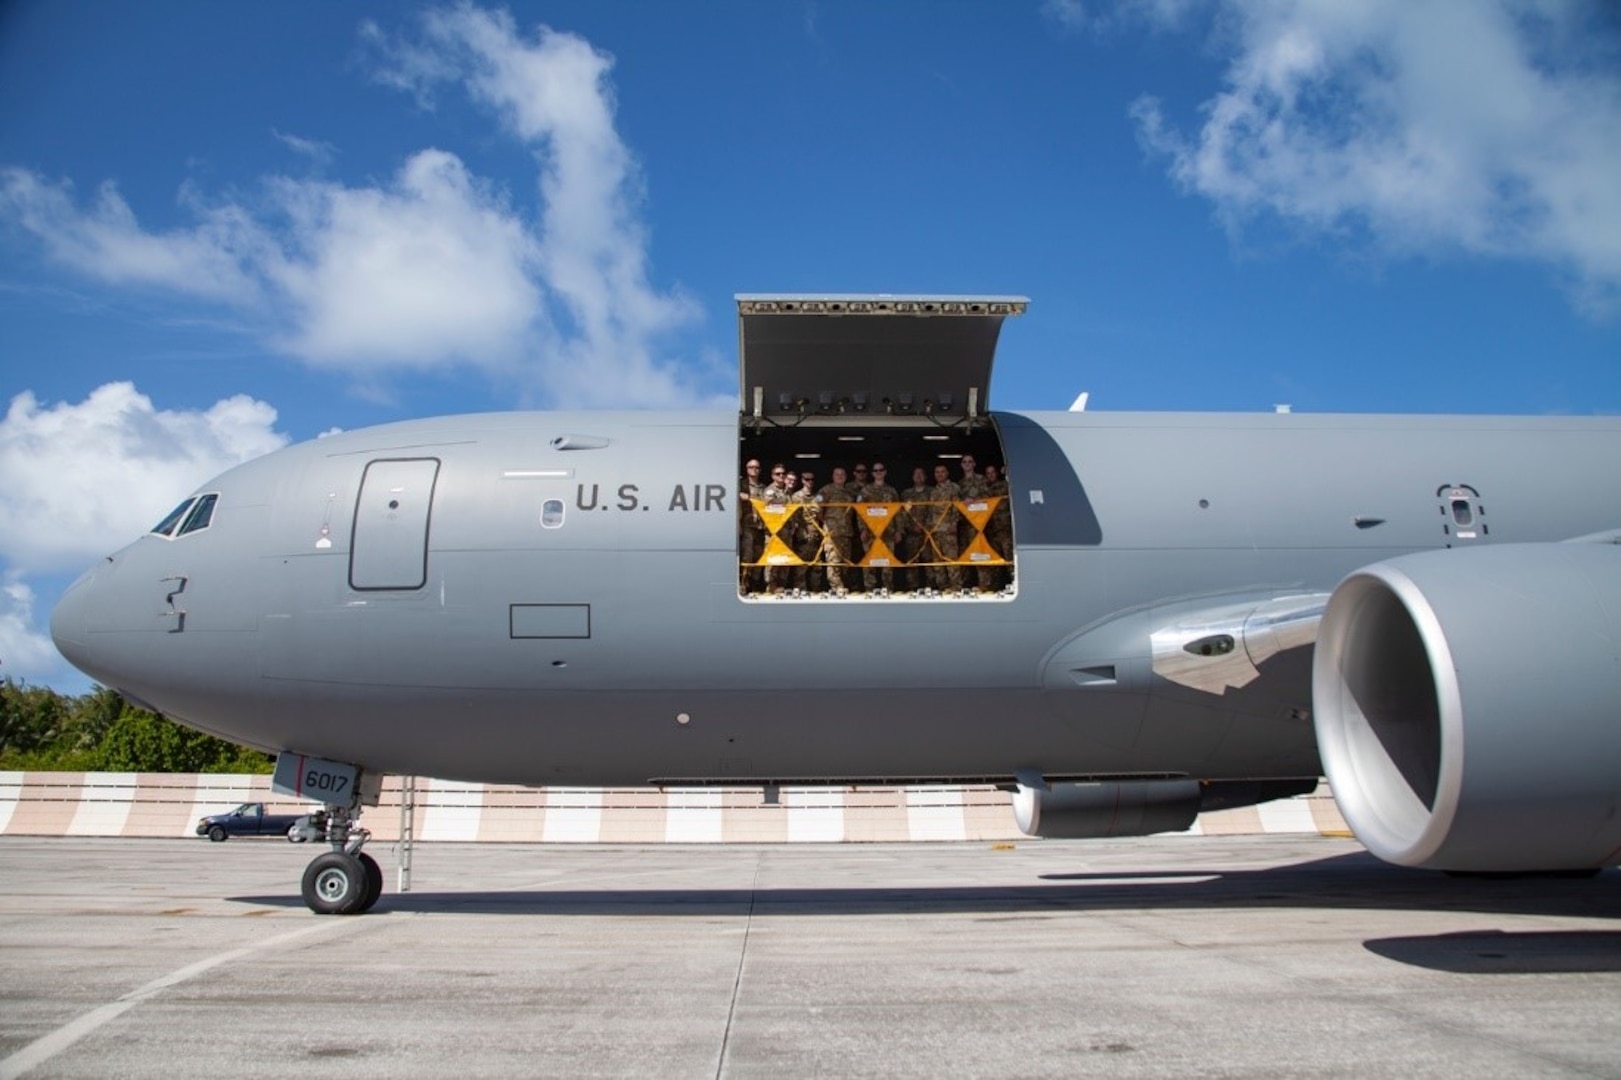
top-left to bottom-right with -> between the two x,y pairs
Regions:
0,6 -> 697,405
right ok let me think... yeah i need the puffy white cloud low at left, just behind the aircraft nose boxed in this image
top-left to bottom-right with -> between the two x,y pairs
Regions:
0,383 -> 287,581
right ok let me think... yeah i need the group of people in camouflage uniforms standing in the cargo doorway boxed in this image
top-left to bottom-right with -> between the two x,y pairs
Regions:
738,454 -> 1013,595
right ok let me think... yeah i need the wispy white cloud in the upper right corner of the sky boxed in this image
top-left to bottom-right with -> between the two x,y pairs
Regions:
1133,0 -> 1621,313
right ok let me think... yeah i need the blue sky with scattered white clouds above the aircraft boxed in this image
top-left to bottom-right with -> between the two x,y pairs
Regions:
0,0 -> 1621,689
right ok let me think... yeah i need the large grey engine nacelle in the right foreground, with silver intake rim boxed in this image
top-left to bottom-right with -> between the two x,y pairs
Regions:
1311,542 -> 1621,871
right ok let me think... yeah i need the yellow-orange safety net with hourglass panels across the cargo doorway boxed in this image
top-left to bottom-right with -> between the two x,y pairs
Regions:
744,495 -> 1008,568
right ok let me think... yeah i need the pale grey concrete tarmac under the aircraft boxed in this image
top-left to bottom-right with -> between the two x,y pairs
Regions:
0,837 -> 1621,1080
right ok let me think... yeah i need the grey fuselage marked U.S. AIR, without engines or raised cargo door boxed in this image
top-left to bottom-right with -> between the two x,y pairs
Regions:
52,414 -> 1621,785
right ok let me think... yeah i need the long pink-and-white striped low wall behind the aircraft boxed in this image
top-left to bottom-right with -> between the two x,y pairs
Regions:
0,772 -> 1350,843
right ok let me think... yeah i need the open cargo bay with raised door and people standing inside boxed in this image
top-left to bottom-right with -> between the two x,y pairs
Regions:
738,295 -> 1028,602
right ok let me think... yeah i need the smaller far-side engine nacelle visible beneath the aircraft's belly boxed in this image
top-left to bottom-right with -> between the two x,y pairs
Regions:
1013,780 -> 1201,840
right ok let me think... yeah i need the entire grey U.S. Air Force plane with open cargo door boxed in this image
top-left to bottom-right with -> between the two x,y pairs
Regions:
52,295 -> 1621,913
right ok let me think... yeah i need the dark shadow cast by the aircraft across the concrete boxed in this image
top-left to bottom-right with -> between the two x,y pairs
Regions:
232,851 -> 1621,973
